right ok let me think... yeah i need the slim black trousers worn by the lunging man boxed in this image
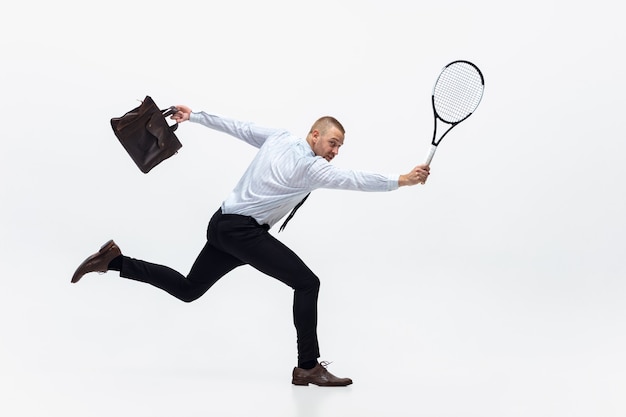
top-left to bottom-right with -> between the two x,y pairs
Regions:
120,209 -> 320,363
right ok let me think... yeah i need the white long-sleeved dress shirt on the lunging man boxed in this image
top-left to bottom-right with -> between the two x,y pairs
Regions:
189,112 -> 399,227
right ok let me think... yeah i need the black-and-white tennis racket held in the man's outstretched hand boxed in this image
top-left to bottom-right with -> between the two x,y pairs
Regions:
426,61 -> 485,165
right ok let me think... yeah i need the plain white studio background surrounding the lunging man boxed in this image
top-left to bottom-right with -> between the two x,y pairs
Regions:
0,0 -> 626,417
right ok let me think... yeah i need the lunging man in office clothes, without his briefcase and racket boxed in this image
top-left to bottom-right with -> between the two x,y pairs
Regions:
72,105 -> 429,386
